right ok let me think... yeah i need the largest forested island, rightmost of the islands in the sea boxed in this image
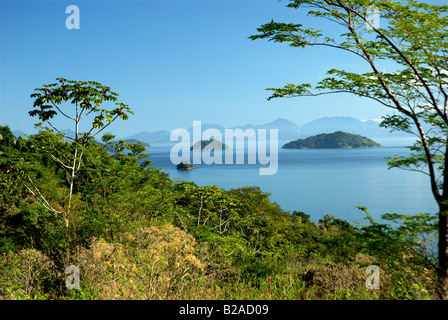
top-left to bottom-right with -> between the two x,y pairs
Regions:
282,131 -> 381,149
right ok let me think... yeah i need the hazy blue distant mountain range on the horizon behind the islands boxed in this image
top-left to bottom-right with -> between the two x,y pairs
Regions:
125,117 -> 411,144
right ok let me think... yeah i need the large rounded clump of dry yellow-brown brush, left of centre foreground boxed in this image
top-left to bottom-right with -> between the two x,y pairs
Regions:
76,225 -> 204,300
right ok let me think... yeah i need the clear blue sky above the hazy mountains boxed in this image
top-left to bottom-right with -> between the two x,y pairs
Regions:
0,0 -> 440,137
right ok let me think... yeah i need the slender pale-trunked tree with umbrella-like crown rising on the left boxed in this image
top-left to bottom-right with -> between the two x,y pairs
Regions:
27,78 -> 133,228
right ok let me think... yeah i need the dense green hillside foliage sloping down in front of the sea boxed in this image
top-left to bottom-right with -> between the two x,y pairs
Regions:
0,127 -> 436,299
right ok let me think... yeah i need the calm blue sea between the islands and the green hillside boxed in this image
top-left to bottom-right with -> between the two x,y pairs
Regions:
147,144 -> 437,222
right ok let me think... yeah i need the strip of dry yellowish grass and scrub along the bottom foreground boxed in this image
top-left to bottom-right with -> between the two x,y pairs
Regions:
0,225 -> 433,300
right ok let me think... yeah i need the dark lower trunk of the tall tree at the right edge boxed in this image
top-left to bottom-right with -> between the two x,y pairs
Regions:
437,208 -> 448,300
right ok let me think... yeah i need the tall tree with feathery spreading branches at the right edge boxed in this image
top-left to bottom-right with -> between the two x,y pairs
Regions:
250,0 -> 448,299
